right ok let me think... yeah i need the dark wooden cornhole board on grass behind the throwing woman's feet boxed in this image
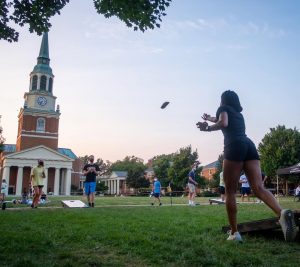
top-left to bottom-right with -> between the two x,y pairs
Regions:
222,210 -> 300,233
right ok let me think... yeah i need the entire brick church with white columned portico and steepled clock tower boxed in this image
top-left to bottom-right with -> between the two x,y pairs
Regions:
0,33 -> 80,195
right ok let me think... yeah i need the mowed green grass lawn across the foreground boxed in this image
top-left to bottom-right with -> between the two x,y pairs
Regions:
0,197 -> 300,267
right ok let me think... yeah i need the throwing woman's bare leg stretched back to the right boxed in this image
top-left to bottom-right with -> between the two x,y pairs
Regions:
244,160 -> 281,217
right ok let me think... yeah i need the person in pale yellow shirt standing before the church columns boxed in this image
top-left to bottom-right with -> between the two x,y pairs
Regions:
30,159 -> 46,208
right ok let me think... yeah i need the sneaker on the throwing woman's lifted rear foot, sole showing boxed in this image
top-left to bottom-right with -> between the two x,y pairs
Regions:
279,210 -> 298,242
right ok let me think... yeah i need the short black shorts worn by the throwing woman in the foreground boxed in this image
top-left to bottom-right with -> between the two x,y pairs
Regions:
224,138 -> 259,161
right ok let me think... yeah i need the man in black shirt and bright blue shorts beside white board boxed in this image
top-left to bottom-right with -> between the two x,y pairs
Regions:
83,155 -> 100,208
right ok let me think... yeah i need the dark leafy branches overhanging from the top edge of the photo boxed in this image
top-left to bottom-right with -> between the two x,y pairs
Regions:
0,0 -> 172,42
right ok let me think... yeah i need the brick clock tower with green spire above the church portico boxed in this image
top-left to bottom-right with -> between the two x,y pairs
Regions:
16,33 -> 60,151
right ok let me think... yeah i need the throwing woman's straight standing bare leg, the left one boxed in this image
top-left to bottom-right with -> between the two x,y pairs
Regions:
223,159 -> 243,233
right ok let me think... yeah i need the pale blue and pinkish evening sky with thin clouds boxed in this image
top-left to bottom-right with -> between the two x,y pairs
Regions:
0,0 -> 300,165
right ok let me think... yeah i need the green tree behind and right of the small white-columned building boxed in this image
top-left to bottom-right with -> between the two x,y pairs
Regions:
110,156 -> 149,188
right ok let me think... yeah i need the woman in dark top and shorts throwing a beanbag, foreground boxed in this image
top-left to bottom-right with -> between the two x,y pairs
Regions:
196,90 -> 297,242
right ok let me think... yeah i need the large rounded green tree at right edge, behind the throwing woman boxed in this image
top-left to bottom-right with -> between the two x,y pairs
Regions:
258,125 -> 300,176
